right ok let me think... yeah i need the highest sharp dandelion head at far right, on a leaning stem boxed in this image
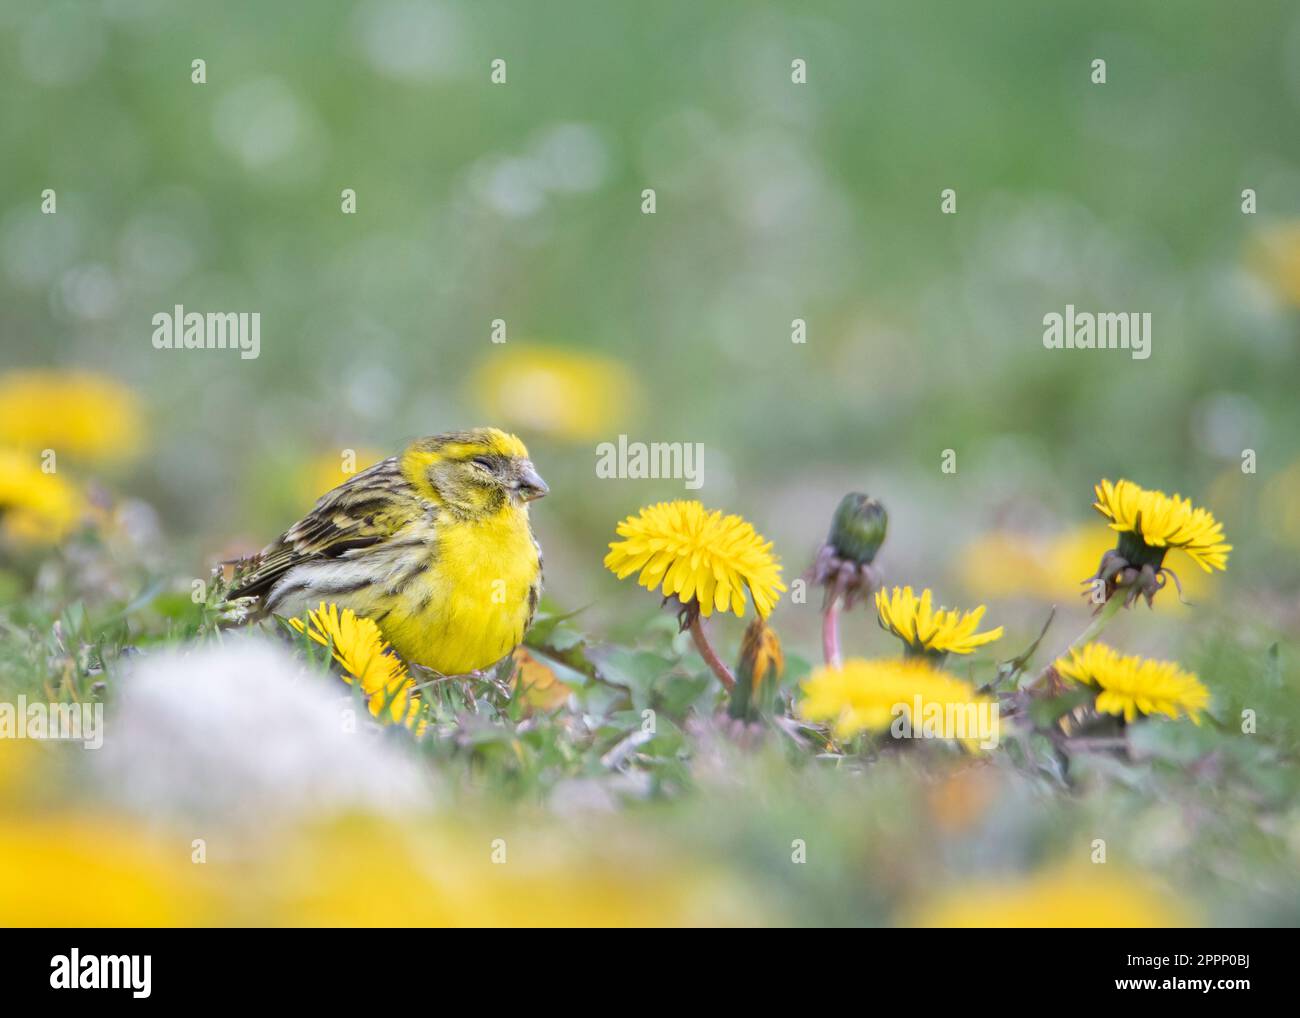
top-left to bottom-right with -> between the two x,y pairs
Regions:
1093,480 -> 1232,572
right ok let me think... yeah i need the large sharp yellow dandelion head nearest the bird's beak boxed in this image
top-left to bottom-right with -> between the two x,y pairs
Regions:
605,501 -> 785,619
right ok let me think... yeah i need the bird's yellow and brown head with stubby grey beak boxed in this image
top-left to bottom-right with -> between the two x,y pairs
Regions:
402,428 -> 550,516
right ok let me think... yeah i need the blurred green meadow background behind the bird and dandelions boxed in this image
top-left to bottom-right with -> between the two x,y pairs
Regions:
0,0 -> 1300,650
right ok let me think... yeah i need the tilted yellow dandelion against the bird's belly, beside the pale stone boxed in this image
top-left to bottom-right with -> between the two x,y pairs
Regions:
289,603 -> 425,733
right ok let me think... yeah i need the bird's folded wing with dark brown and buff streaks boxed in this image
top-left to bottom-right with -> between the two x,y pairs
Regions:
228,456 -> 415,598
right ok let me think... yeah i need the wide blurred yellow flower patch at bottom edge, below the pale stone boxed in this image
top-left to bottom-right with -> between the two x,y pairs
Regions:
261,818 -> 759,927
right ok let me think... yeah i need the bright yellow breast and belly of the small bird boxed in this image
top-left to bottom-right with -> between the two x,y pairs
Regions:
380,506 -> 541,675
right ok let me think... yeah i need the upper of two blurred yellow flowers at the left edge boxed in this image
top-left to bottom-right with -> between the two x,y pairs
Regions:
0,371 -> 144,463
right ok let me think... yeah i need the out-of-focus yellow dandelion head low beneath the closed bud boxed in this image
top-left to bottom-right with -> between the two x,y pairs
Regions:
800,658 -> 992,745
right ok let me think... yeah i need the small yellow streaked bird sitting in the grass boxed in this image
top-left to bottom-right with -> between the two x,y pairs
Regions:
229,428 -> 550,675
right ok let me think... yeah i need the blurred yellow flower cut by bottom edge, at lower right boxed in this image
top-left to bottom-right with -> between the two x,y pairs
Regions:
904,866 -> 1186,928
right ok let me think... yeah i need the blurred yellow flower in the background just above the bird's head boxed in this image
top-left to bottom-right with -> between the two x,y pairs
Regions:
475,347 -> 638,442
